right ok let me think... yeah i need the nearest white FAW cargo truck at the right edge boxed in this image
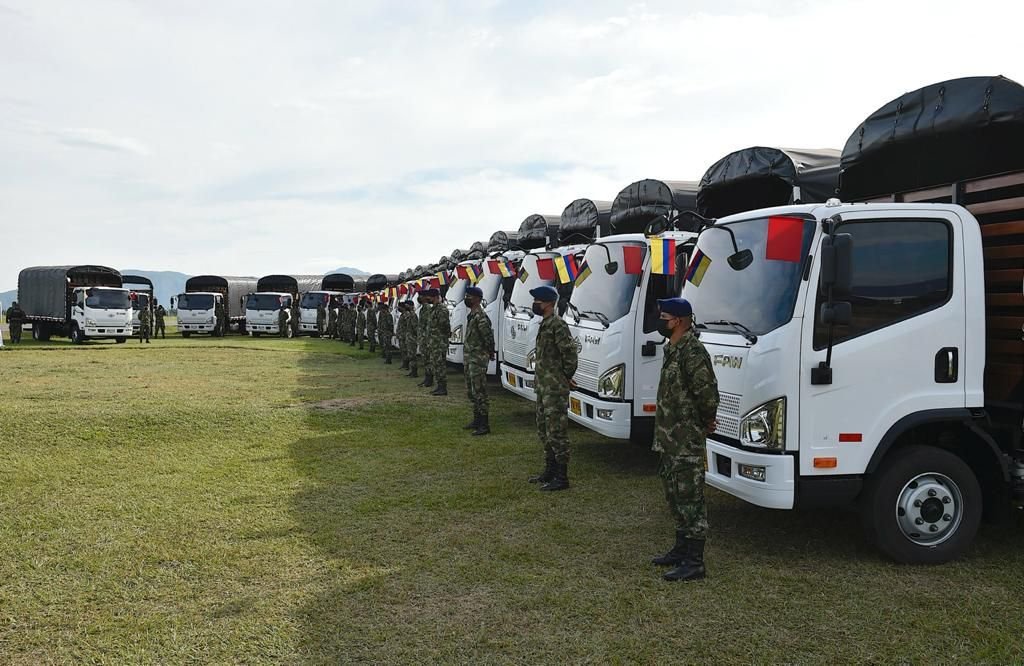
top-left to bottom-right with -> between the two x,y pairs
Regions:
683,77 -> 1024,564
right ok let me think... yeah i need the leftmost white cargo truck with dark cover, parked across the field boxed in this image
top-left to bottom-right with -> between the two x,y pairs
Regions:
17,265 -> 132,344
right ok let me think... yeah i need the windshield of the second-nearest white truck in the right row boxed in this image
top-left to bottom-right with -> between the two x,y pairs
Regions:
569,242 -> 647,322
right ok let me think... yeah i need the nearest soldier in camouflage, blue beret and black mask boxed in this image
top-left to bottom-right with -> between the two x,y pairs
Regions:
651,298 -> 718,581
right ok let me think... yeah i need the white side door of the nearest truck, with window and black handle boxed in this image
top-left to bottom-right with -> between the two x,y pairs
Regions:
800,210 -> 966,475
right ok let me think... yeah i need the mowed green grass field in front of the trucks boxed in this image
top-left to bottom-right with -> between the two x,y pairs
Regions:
0,337 -> 1024,664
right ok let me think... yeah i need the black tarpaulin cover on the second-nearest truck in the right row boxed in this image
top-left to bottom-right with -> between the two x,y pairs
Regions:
697,145 -> 841,218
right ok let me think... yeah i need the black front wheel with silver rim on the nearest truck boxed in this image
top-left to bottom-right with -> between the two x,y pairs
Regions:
861,446 -> 983,565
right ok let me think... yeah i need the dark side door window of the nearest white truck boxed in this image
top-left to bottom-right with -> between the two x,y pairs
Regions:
814,219 -> 952,349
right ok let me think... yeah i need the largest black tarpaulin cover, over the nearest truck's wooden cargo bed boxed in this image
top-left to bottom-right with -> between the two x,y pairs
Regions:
840,76 -> 1024,196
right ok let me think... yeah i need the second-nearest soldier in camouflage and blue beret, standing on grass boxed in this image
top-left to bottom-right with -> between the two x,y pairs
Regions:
528,287 -> 579,491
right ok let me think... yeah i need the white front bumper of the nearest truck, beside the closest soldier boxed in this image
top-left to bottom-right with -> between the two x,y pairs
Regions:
705,440 -> 797,509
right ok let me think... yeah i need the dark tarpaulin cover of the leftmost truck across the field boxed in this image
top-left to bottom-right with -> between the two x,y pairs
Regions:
17,265 -> 123,321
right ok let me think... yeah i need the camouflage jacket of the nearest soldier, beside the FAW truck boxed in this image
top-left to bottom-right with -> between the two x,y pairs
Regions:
651,331 -> 718,456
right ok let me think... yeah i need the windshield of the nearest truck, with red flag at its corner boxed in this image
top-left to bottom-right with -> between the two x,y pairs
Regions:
683,217 -> 814,335
